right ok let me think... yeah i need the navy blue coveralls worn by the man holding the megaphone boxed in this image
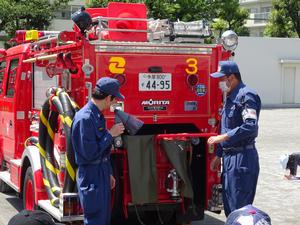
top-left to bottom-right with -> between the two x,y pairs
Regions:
72,101 -> 113,225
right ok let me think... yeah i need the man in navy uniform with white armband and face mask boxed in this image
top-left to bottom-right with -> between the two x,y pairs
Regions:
208,61 -> 261,216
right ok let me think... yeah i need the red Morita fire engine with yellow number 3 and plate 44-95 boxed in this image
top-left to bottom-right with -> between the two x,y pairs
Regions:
0,3 -> 237,223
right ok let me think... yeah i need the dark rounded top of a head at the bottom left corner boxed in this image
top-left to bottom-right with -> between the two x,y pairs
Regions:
7,210 -> 63,225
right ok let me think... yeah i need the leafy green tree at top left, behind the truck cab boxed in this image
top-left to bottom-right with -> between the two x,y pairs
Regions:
0,0 -> 70,37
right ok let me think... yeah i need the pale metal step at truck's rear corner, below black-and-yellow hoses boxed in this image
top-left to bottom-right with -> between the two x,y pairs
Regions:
38,200 -> 83,222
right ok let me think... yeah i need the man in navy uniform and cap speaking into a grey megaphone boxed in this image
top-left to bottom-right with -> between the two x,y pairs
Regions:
72,77 -> 124,225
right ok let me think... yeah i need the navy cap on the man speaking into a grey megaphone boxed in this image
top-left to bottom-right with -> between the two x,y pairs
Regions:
95,77 -> 125,100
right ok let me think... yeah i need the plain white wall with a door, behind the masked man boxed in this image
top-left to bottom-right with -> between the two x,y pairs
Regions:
234,37 -> 300,107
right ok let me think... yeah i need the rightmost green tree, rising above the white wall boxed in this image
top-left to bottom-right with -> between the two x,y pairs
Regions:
264,0 -> 300,37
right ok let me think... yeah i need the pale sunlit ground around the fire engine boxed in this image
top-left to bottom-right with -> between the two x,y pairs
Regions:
0,109 -> 300,225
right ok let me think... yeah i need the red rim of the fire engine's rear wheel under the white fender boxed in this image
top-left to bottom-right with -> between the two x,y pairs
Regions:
23,167 -> 37,210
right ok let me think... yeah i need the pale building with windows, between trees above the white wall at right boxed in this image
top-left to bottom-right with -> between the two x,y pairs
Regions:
239,0 -> 272,37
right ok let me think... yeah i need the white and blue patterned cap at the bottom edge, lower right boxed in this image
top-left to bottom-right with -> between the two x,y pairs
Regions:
225,205 -> 271,225
